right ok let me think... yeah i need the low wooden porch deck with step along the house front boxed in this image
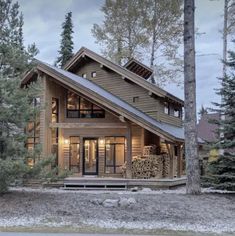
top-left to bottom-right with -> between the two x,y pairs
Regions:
64,176 -> 186,190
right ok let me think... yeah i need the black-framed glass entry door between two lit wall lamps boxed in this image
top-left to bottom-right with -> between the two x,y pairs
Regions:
83,138 -> 98,175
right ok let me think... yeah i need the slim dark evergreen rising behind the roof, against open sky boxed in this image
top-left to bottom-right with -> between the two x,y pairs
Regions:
56,12 -> 73,67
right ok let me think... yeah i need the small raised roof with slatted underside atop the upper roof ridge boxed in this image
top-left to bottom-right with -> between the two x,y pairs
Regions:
124,58 -> 153,79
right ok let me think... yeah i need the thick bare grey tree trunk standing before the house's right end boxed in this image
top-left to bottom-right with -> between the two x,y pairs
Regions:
184,0 -> 201,194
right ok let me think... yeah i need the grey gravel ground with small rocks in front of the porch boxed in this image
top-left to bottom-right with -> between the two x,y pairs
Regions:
0,188 -> 235,233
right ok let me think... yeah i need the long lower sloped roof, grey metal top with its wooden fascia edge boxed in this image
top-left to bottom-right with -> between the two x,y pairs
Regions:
22,62 -> 184,141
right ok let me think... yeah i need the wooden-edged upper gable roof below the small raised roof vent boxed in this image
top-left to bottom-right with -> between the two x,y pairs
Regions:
64,47 -> 184,105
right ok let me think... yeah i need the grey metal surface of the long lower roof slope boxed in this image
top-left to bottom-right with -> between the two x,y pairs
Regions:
36,62 -> 184,140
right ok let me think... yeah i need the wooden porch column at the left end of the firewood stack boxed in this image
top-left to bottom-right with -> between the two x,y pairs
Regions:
126,123 -> 132,179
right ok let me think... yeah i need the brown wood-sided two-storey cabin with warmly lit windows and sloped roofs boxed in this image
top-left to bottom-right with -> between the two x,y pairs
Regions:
22,47 -> 184,178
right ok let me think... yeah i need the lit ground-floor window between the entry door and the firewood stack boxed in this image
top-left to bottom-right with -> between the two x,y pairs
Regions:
105,137 -> 125,174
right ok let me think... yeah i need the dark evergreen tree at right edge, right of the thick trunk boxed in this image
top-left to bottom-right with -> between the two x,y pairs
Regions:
207,47 -> 235,191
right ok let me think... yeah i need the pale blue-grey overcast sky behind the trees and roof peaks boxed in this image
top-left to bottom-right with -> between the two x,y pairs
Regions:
18,0 -> 224,113
